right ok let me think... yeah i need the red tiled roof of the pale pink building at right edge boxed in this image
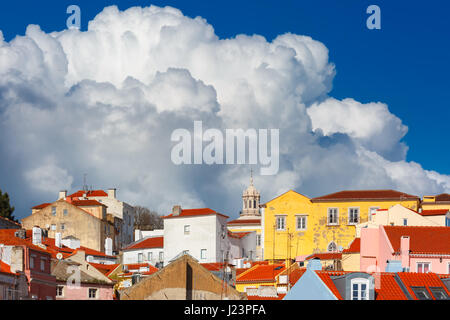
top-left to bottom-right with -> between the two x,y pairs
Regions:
383,226 -> 450,254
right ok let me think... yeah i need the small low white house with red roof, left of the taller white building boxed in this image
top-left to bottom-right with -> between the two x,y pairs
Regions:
122,236 -> 164,267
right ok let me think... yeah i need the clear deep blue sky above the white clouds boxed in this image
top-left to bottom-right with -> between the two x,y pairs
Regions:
0,0 -> 450,174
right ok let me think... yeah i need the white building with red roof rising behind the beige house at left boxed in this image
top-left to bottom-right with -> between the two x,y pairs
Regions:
59,188 -> 135,248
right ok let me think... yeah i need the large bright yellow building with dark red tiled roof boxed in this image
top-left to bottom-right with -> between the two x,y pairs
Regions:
263,190 -> 420,260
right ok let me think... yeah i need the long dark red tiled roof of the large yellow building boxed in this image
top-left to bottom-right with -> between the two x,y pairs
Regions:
311,190 -> 420,202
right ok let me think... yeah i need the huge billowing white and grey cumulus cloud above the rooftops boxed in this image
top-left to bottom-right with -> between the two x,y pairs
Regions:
0,6 -> 450,217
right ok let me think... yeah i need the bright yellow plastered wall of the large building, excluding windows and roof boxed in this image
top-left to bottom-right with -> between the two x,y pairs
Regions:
264,190 -> 418,260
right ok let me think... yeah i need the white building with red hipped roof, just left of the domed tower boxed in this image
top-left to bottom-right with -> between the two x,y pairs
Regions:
163,206 -> 256,265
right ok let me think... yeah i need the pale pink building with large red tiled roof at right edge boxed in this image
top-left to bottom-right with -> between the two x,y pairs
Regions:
361,226 -> 450,274
